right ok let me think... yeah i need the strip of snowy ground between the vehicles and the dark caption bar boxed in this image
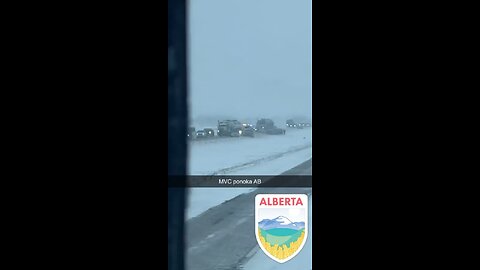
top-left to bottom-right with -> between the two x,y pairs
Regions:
188,128 -> 312,175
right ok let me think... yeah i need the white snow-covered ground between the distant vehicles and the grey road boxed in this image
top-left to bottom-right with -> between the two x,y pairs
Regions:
186,129 -> 312,219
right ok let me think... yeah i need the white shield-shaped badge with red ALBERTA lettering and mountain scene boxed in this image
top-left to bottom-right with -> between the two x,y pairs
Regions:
255,194 -> 308,263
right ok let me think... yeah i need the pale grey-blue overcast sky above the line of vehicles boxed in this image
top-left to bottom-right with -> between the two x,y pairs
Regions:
189,0 -> 312,124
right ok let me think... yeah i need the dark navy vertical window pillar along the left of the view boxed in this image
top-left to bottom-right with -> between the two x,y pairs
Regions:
167,0 -> 188,270
